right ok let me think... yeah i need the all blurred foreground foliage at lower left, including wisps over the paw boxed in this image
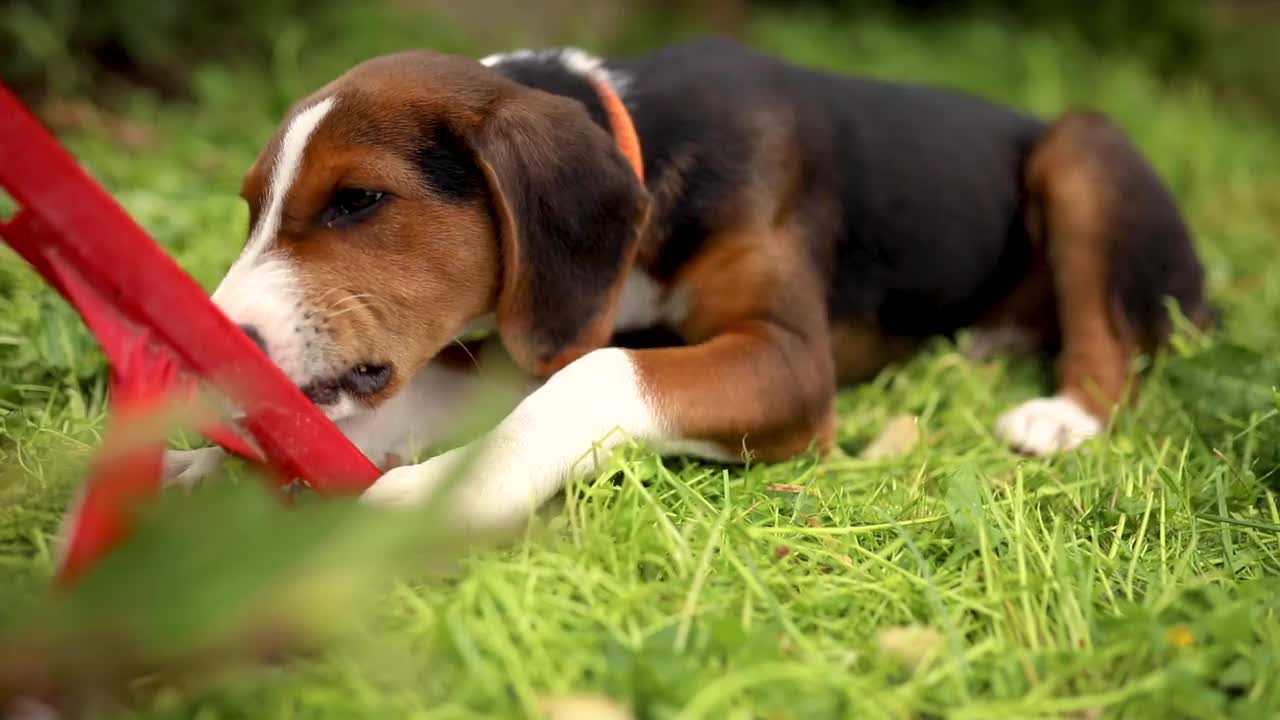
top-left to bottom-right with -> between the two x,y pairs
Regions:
0,354 -> 524,717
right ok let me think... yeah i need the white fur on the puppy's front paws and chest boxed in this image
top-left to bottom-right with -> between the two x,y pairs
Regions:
165,348 -> 741,515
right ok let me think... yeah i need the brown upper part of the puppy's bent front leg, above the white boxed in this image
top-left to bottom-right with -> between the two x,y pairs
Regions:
635,219 -> 835,461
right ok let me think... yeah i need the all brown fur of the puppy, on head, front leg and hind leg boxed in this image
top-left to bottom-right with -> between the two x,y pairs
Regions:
235,53 -> 1203,461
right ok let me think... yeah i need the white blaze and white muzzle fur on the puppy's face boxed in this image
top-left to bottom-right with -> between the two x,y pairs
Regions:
211,96 -> 343,392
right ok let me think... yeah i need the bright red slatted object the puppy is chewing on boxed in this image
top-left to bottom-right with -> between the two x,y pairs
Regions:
0,85 -> 380,583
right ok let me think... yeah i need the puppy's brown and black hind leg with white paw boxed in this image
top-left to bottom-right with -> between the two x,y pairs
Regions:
997,113 -> 1204,455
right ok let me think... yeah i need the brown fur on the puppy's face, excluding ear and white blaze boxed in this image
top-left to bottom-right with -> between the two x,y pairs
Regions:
243,56 -> 499,405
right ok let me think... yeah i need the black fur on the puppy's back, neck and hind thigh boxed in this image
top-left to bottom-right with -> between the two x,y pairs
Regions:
497,40 -> 1202,348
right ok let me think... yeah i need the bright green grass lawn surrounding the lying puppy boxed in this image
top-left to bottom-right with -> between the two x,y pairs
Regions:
0,5 -> 1280,720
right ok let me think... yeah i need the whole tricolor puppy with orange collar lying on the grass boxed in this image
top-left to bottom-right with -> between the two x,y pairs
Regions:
174,41 -> 1208,523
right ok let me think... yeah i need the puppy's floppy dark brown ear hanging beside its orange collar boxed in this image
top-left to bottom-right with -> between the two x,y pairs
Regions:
475,90 -> 648,375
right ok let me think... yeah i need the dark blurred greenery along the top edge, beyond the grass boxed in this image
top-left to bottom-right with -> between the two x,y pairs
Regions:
0,0 -> 1280,116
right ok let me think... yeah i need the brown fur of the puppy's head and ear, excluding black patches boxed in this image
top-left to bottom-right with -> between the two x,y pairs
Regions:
243,53 -> 643,405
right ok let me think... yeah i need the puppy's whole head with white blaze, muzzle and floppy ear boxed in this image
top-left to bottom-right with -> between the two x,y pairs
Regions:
212,53 -> 645,419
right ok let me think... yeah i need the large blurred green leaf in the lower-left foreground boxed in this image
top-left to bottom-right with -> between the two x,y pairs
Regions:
0,474 -> 461,710
